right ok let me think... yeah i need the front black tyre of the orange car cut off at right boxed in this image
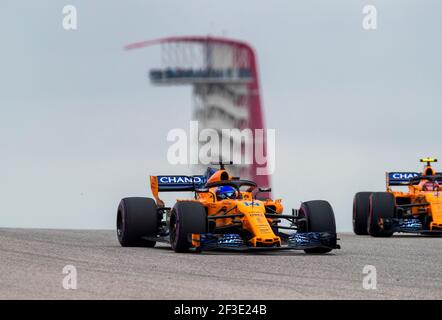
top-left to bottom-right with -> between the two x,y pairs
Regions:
367,192 -> 395,237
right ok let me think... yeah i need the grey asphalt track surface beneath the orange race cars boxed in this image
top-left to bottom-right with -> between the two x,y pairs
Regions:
0,229 -> 442,299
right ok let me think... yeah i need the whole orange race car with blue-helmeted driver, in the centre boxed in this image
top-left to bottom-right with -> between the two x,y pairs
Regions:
117,162 -> 339,253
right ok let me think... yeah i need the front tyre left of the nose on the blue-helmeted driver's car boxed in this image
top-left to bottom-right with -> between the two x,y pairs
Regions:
170,201 -> 207,252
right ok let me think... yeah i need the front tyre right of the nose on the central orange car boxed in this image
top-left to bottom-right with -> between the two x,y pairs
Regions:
299,200 -> 336,253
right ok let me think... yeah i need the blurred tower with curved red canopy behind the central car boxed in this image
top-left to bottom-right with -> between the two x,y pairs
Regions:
126,36 -> 270,186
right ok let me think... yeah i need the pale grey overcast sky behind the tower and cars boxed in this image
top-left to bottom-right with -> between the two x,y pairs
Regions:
0,0 -> 442,231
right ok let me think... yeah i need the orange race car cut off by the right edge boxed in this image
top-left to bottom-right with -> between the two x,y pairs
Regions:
353,158 -> 442,237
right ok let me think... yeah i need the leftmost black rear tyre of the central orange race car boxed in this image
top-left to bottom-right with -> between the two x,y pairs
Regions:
117,197 -> 159,247
